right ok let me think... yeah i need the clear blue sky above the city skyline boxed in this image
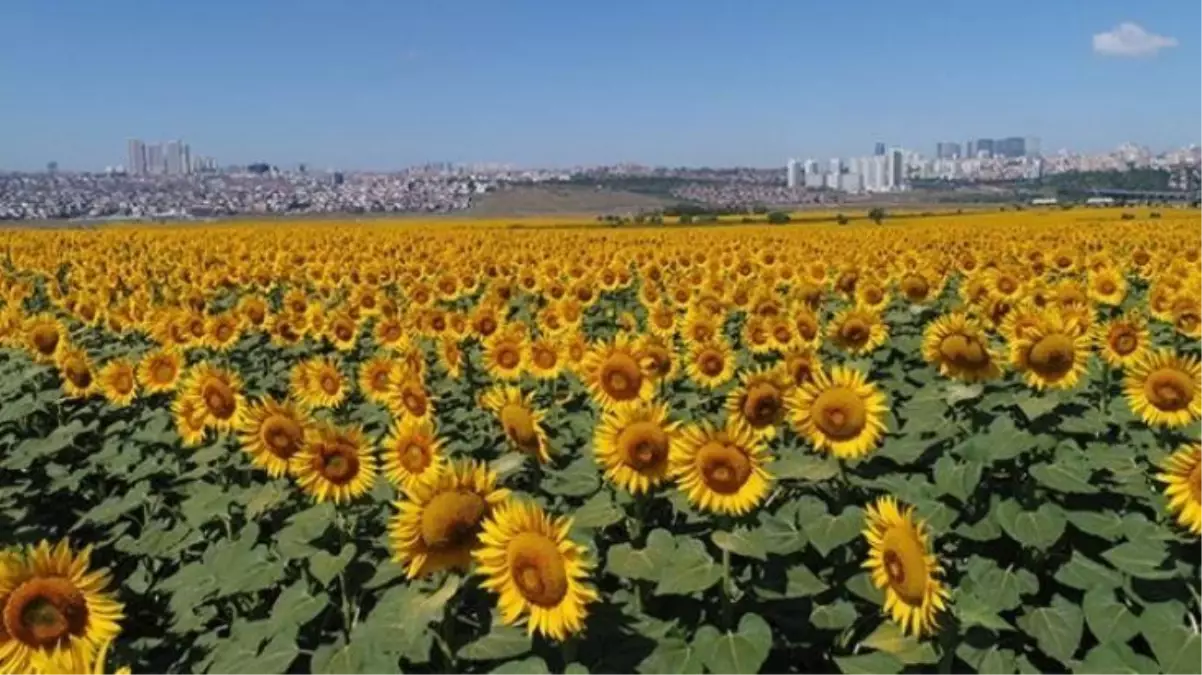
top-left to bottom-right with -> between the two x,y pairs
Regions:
0,0 -> 1202,169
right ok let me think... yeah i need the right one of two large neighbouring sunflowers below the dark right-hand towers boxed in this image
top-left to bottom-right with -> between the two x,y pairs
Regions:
1010,311 -> 1090,389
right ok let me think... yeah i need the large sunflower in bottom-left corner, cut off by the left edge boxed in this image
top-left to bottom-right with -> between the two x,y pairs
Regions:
0,540 -> 124,675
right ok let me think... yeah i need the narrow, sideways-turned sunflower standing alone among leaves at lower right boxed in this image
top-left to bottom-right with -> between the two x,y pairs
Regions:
864,496 -> 948,637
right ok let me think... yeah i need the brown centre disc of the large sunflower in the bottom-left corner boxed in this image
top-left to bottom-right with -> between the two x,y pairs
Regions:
4,577 -> 88,650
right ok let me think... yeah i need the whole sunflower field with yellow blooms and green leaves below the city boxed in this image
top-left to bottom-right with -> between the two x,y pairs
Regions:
0,210 -> 1202,675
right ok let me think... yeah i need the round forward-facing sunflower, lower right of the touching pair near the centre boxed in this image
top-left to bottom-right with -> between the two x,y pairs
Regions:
668,420 -> 772,515
